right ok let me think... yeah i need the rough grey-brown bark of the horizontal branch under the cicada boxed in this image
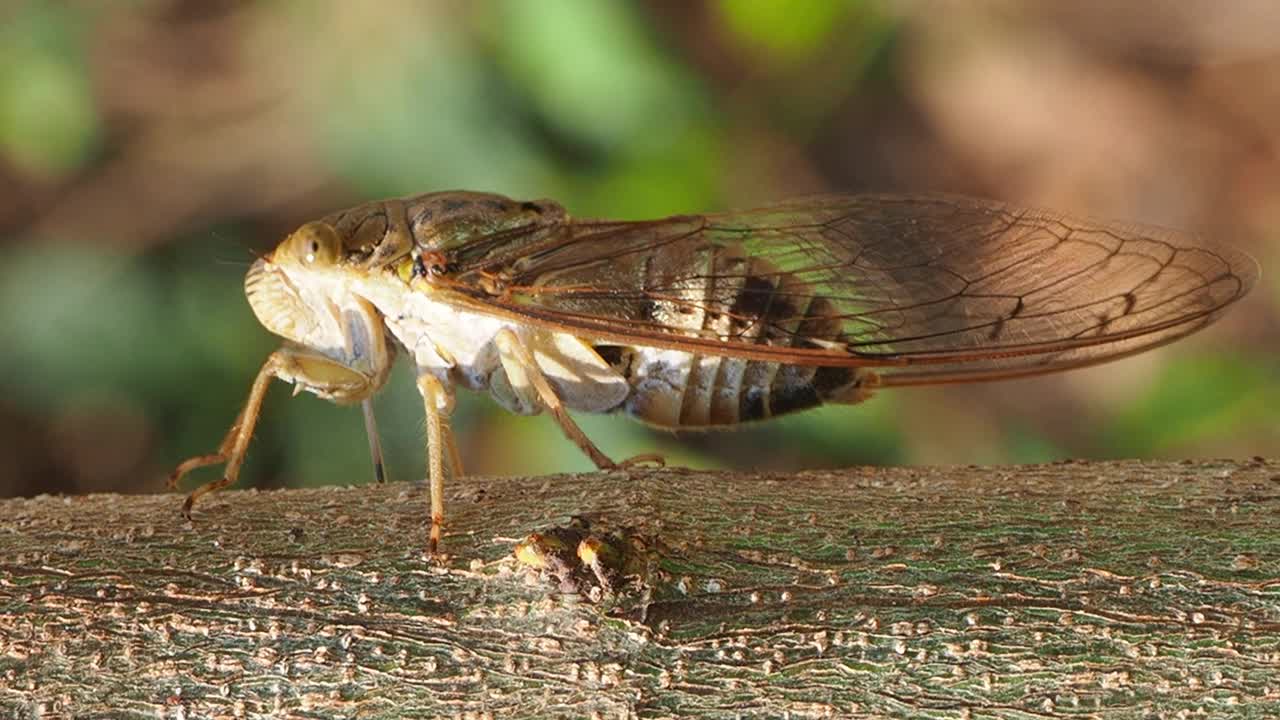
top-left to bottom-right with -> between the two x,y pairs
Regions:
0,460 -> 1280,717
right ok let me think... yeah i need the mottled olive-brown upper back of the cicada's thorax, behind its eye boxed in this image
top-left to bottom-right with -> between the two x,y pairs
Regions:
323,191 -> 564,268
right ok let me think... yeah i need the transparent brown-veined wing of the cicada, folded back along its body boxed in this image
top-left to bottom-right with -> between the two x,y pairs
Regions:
435,195 -> 1258,384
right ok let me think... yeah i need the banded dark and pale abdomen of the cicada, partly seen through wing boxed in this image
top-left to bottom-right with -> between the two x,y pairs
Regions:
596,245 -> 878,428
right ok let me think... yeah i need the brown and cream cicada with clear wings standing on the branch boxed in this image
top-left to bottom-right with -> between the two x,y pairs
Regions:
170,192 -> 1258,552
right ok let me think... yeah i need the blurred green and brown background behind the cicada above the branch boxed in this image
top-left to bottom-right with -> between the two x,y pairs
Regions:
0,0 -> 1280,496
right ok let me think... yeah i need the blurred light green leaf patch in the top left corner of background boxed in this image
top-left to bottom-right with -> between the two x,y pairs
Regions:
0,3 -> 99,177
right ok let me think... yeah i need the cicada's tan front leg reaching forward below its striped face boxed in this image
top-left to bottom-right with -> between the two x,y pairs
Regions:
169,346 -> 379,519
